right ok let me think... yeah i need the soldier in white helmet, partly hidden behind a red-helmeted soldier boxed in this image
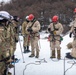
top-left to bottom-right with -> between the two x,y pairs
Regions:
22,16 -> 30,53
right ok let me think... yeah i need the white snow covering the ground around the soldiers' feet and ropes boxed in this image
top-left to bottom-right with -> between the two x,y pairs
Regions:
9,32 -> 76,75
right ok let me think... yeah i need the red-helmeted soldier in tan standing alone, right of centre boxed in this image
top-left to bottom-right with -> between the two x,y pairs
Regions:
48,15 -> 63,59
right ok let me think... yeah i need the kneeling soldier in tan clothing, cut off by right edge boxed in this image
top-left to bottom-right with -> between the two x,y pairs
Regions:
66,8 -> 76,59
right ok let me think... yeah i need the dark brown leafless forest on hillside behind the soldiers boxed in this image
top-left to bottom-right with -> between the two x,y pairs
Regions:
0,0 -> 76,32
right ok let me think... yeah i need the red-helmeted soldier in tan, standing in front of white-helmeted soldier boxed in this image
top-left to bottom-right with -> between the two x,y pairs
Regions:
26,14 -> 40,58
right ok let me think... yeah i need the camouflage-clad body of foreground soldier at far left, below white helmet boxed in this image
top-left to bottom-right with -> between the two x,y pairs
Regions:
0,19 -> 12,75
